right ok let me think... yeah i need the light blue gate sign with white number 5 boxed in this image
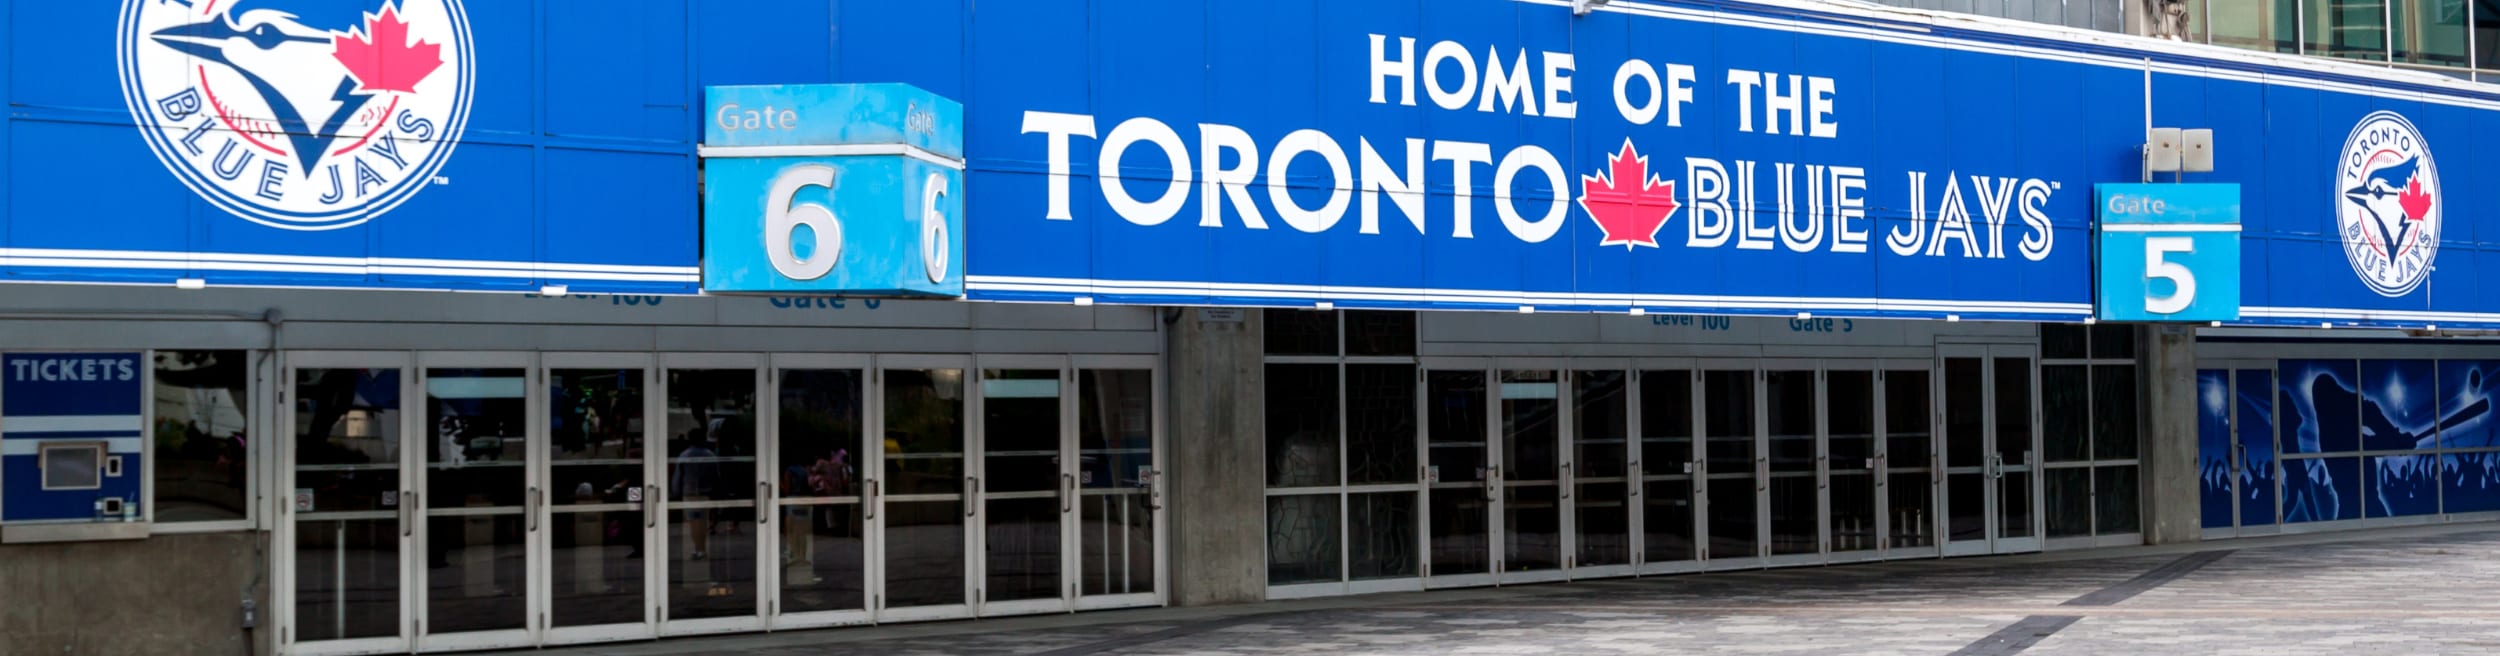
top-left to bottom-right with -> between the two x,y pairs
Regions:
2093,185 -> 2240,320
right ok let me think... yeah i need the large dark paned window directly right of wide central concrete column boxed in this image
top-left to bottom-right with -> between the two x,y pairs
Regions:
1263,310 -> 1423,586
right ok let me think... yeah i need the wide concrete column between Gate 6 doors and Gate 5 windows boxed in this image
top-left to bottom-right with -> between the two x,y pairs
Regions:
1165,310 -> 1268,606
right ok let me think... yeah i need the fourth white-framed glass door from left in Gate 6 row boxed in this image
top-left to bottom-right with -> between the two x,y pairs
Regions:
658,353 -> 773,636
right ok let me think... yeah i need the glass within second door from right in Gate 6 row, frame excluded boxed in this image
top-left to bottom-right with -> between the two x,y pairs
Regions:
980,368 -> 1075,601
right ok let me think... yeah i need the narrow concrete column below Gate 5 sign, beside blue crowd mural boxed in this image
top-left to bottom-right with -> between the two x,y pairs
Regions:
2138,325 -> 2205,543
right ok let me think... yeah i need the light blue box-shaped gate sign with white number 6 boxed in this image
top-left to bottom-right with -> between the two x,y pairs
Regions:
703,85 -> 975,298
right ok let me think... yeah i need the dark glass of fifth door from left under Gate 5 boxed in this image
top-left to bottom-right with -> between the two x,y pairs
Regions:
1703,371 -> 1760,558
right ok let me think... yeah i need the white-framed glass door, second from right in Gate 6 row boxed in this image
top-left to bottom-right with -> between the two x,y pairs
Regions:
973,358 -> 1078,616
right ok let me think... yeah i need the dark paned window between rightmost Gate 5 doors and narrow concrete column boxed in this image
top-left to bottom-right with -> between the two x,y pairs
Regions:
2040,323 -> 2143,541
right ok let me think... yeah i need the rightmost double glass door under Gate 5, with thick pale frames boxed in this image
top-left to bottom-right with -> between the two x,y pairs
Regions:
1938,343 -> 2040,556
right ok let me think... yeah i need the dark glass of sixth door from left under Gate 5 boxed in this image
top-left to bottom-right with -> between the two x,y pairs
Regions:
1763,371 -> 1823,556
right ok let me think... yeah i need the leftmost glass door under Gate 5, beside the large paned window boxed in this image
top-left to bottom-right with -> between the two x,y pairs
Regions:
1423,366 -> 1500,588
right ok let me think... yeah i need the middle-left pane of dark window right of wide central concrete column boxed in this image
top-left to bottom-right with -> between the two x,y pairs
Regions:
1268,360 -> 1338,488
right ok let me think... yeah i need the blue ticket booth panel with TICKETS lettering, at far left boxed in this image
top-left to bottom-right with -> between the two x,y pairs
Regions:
0,353 -> 148,523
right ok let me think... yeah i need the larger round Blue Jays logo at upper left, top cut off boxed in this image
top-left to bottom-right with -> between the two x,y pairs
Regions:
120,0 -> 475,230
